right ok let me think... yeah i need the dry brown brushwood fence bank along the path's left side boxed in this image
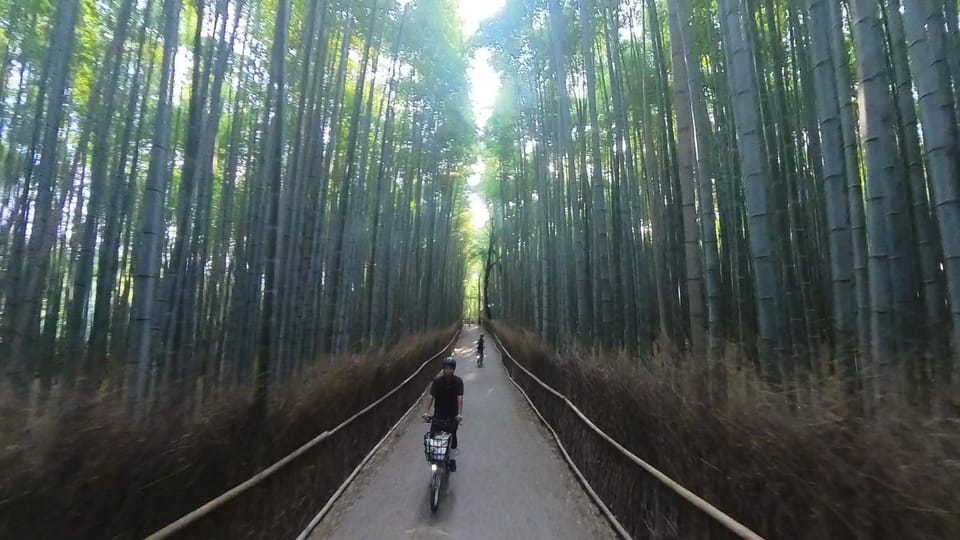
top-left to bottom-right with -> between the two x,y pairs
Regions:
0,327 -> 455,539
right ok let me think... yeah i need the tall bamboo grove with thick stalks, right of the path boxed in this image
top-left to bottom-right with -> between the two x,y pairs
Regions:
476,0 -> 960,406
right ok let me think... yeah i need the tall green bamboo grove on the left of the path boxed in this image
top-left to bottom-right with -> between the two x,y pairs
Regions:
0,0 -> 475,402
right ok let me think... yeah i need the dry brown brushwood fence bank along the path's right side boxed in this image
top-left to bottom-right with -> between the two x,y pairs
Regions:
492,323 -> 960,539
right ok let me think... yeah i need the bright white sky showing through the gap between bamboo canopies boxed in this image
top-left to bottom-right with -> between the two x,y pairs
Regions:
460,0 -> 504,229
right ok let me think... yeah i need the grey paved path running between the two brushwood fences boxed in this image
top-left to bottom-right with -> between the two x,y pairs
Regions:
310,326 -> 617,540
